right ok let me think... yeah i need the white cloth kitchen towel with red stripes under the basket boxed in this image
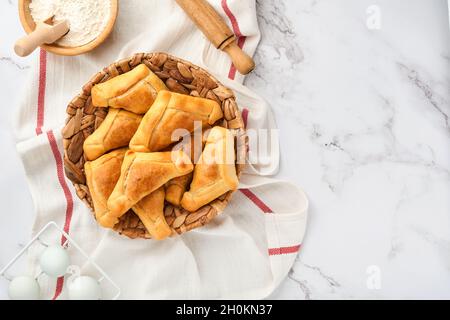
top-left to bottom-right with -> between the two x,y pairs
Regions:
15,0 -> 308,299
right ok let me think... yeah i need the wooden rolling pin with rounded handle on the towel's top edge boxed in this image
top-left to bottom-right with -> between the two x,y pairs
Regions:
176,0 -> 255,74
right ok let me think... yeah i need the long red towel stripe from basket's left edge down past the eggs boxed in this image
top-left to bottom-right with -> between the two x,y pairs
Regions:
47,131 -> 73,300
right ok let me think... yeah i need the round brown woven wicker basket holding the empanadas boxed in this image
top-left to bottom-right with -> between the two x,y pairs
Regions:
62,53 -> 247,239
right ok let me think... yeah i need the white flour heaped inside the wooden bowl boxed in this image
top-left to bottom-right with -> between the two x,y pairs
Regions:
30,0 -> 111,47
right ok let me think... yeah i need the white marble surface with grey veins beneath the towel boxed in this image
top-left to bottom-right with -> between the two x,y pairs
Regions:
0,0 -> 450,299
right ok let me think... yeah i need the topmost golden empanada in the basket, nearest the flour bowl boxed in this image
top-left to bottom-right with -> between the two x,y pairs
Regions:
91,64 -> 167,114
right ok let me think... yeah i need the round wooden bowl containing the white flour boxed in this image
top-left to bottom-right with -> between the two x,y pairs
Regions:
19,0 -> 119,56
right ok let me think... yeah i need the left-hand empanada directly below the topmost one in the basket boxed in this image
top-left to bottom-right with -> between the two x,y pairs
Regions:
83,109 -> 142,160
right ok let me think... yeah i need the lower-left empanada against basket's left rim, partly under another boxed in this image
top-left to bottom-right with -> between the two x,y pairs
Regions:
84,148 -> 128,225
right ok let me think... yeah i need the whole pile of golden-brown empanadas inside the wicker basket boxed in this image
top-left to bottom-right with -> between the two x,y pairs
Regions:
83,64 -> 238,239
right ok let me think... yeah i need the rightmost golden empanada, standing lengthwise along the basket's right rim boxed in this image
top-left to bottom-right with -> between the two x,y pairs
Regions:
181,127 -> 239,212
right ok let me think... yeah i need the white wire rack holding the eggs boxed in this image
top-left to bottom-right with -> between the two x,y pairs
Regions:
0,221 -> 121,300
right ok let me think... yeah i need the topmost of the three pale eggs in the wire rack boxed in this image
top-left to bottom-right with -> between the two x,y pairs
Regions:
39,246 -> 70,277
